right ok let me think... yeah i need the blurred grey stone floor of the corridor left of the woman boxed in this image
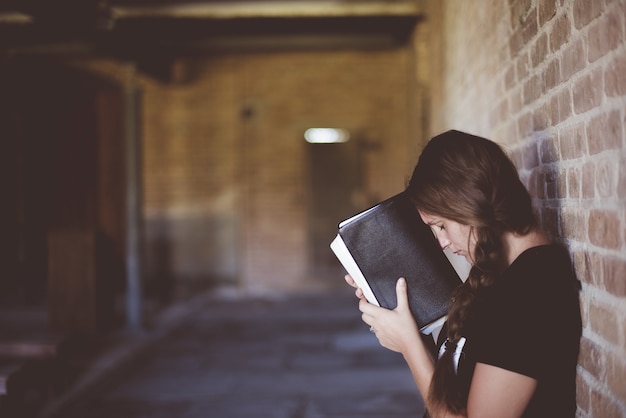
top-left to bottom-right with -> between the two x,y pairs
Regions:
45,289 -> 423,418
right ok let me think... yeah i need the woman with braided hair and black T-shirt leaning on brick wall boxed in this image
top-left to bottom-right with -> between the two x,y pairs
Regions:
346,131 -> 581,418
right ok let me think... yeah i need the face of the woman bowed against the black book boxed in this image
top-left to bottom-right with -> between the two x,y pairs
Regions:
419,210 -> 476,264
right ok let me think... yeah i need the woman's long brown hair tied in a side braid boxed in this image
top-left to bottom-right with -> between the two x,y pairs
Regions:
407,131 -> 534,413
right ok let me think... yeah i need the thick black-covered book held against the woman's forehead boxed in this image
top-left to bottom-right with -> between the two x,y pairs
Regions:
330,192 -> 462,336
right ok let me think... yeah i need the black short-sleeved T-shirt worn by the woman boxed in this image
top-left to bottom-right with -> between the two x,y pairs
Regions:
436,245 -> 582,418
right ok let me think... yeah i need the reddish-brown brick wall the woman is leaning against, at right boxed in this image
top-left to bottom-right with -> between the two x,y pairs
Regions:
425,0 -> 626,417
